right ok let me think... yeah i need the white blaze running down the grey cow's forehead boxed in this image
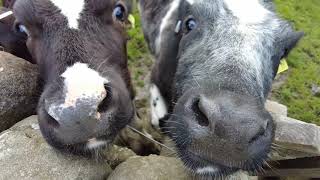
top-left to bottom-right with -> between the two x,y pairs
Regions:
224,0 -> 279,94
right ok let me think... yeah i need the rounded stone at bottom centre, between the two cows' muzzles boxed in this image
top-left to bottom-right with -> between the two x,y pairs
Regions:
108,155 -> 192,180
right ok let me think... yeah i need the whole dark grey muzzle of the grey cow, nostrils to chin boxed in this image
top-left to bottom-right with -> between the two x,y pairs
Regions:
163,89 -> 274,169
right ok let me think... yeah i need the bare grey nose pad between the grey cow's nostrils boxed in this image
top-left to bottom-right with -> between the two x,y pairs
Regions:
192,95 -> 269,150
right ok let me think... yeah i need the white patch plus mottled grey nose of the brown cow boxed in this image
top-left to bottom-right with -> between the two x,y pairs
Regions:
44,63 -> 109,137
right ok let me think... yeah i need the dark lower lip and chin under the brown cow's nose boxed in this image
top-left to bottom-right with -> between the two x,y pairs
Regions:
38,95 -> 134,157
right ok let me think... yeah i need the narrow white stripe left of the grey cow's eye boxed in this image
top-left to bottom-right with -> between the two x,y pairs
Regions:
156,0 -> 181,53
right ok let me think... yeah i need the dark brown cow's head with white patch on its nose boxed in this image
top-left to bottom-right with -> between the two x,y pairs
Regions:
14,0 -> 134,154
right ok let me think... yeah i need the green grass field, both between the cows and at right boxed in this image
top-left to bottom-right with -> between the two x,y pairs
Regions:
128,0 -> 320,125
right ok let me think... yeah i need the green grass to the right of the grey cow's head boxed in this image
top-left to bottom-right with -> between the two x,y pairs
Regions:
273,0 -> 320,125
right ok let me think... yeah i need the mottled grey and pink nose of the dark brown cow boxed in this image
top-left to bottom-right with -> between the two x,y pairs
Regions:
45,82 -> 112,144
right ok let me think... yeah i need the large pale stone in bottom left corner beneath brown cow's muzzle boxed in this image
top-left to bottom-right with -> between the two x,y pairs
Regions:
0,116 -> 112,179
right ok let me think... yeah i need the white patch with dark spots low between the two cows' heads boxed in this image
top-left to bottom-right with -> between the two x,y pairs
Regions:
150,84 -> 168,127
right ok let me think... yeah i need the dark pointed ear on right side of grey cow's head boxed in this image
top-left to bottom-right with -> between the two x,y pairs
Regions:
280,31 -> 304,59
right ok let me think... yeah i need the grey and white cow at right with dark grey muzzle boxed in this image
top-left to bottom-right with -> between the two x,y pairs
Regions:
139,0 -> 303,176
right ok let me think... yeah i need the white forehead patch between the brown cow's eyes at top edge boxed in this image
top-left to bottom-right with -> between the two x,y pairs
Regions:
50,0 -> 85,29
